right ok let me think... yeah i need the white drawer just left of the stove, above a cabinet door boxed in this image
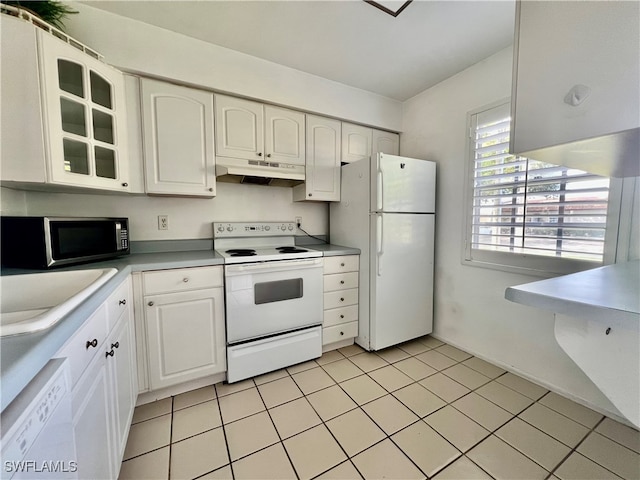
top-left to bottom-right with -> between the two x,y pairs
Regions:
142,267 -> 223,295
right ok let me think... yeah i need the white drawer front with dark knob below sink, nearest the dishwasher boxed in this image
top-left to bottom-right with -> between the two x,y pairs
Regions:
55,303 -> 108,385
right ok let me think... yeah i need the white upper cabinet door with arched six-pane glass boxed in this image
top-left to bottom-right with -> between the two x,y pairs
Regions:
38,32 -> 129,192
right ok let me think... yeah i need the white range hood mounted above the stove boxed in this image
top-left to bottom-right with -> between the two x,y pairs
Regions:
216,157 -> 305,187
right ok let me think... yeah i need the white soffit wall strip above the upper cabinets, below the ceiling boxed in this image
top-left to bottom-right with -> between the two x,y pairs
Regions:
65,3 -> 402,131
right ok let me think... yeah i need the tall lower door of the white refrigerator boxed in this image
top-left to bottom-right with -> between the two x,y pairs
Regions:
369,213 -> 435,350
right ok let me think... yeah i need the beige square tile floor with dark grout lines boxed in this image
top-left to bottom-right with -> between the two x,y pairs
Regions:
120,336 -> 640,480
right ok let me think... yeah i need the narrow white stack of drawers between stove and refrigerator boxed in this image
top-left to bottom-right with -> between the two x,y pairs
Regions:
322,255 -> 360,352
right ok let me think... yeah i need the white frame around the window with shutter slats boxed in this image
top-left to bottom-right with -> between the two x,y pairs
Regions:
462,97 -> 623,278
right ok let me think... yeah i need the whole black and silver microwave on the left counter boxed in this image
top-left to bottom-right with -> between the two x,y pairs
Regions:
0,216 -> 129,268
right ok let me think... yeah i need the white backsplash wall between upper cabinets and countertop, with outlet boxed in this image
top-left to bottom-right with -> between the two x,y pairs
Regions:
7,182 -> 329,241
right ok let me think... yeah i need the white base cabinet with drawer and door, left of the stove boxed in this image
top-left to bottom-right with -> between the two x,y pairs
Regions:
140,266 -> 226,391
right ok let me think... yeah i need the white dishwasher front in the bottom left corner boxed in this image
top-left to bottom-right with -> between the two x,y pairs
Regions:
0,359 -> 78,480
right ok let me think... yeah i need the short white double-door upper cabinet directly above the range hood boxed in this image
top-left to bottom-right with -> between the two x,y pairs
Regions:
215,95 -> 305,165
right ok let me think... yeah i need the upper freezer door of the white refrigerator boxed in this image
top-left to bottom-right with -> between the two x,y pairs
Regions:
371,153 -> 436,213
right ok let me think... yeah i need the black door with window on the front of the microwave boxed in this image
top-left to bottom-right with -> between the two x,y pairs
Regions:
50,220 -> 118,260
